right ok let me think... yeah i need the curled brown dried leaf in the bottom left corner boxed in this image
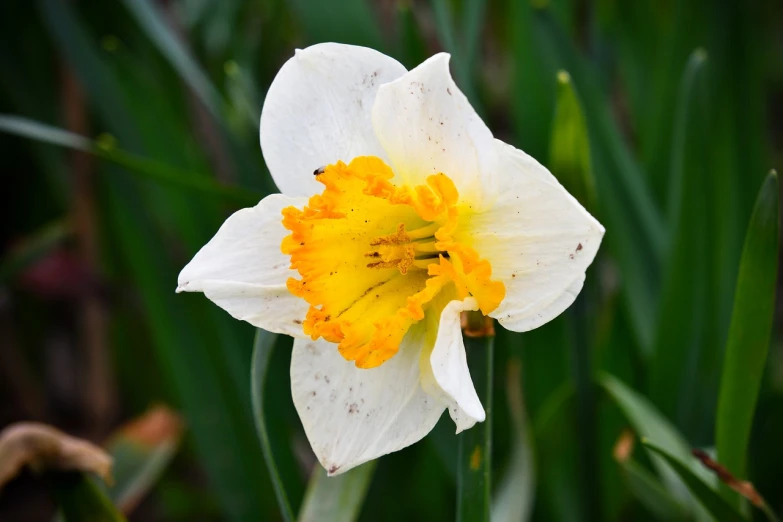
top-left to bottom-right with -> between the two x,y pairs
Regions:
0,422 -> 112,489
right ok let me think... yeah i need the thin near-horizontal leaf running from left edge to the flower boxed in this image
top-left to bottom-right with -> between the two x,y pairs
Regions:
0,114 -> 262,205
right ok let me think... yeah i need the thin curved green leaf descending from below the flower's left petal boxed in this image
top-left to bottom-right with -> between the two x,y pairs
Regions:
250,328 -> 295,522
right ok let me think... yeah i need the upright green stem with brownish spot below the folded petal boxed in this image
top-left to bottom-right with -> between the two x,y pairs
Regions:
457,336 -> 494,522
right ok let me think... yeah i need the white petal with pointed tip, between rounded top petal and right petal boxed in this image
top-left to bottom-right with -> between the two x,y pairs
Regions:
372,53 -> 495,204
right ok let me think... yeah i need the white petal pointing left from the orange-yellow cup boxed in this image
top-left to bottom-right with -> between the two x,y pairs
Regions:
177,194 -> 309,336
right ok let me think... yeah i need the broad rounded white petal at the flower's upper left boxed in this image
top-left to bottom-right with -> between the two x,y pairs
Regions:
260,43 -> 405,196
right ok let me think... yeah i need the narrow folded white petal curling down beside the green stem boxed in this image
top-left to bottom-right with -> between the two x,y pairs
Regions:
425,297 -> 486,433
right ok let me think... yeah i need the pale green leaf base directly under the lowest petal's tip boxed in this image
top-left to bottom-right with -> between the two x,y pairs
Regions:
299,461 -> 376,522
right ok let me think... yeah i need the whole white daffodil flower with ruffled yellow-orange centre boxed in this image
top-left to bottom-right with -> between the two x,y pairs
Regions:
177,43 -> 604,475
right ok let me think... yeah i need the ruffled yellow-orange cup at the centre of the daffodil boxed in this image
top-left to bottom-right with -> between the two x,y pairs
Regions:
281,156 -> 505,368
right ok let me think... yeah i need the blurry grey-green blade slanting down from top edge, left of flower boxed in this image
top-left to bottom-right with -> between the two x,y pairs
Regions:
123,0 -> 225,120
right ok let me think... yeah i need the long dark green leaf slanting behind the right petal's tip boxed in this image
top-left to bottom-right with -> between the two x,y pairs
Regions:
532,9 -> 666,356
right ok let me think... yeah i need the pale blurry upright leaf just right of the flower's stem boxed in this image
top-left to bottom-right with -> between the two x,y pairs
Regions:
492,359 -> 536,522
